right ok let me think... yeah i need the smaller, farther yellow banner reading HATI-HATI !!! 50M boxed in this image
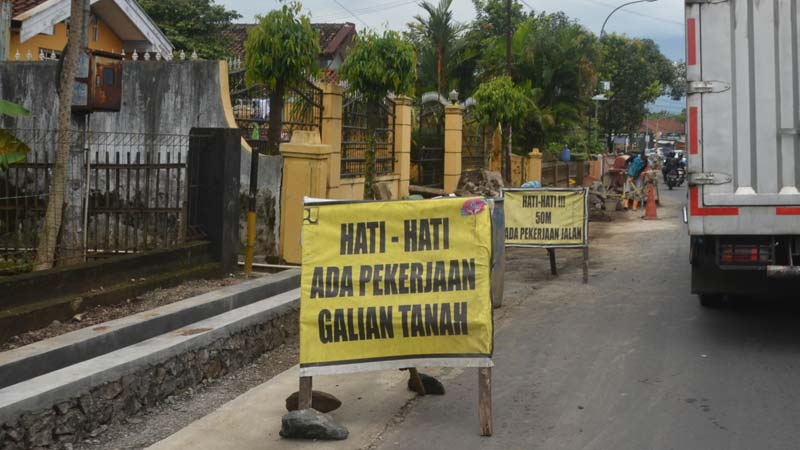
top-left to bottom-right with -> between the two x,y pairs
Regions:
503,189 -> 589,247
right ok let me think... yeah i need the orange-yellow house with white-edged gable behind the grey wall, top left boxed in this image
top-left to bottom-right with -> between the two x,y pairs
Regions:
9,0 -> 174,60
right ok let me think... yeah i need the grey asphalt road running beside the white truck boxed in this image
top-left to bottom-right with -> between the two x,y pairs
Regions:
375,189 -> 800,450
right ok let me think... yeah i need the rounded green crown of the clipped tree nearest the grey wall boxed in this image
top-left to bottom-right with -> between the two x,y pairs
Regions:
244,2 -> 320,89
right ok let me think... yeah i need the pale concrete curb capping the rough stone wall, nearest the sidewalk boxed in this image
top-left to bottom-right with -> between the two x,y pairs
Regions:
0,289 -> 300,423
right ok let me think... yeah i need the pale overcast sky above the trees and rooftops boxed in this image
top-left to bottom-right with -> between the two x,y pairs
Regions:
215,0 -> 685,111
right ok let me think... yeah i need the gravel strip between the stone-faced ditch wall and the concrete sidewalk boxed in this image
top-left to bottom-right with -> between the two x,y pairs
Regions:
79,337 -> 299,450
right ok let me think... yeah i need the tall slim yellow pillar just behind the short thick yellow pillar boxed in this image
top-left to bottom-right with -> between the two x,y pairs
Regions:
320,83 -> 344,199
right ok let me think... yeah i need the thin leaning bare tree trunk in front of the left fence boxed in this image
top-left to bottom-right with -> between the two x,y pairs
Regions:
34,0 -> 89,270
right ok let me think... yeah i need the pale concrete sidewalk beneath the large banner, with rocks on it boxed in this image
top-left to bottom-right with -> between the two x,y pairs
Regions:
149,366 -> 466,450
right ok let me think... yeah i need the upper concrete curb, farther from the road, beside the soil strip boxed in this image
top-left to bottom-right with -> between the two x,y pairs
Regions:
0,269 -> 300,392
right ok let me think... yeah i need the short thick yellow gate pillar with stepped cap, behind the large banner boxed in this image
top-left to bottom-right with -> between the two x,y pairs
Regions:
280,131 -> 331,264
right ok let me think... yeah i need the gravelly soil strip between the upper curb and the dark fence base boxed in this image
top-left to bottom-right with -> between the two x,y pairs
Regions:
0,272 -> 263,352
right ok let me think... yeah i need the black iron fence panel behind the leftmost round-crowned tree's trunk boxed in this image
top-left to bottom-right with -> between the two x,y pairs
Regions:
229,70 -> 322,154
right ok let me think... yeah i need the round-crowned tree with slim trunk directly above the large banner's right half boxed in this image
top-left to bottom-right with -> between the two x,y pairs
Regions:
339,31 -> 417,200
